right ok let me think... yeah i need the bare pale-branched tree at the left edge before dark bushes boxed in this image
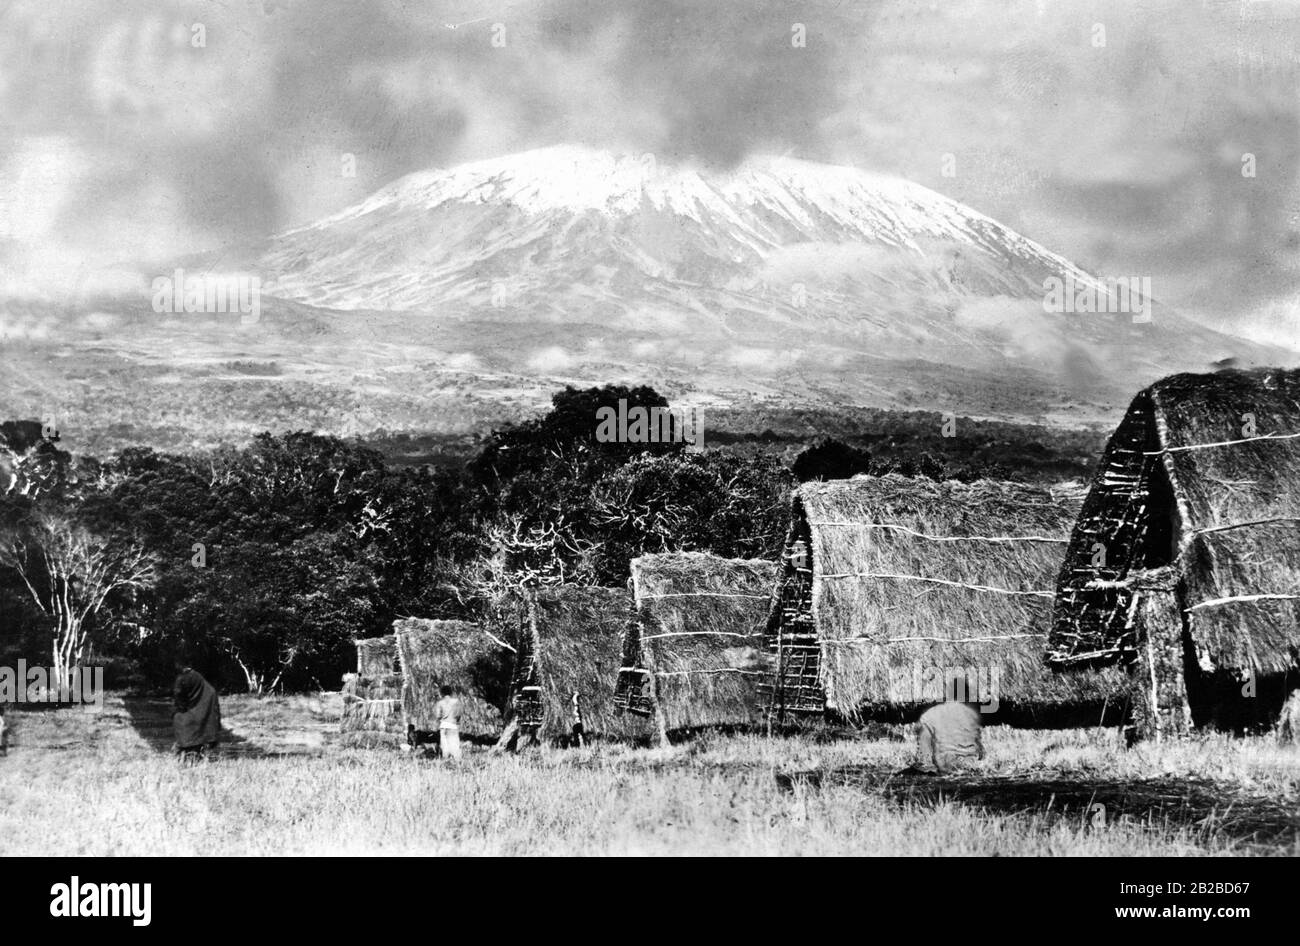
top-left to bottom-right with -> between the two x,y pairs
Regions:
0,512 -> 157,689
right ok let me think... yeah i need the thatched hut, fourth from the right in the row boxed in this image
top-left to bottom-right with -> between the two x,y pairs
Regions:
498,585 -> 649,741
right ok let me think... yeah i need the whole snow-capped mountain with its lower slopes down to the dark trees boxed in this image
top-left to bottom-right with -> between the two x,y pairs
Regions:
0,147 -> 1290,457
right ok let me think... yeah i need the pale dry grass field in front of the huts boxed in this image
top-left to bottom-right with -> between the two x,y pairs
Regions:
0,694 -> 1300,856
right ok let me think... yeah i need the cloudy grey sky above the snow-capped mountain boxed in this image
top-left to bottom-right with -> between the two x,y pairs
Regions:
0,0 -> 1300,348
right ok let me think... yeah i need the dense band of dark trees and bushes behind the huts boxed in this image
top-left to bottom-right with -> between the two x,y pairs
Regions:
0,386 -> 788,690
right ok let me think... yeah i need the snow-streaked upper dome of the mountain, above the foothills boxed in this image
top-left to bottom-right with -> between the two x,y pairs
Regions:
261,146 -> 1088,314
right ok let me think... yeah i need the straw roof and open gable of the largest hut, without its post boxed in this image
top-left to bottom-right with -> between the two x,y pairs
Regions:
1052,369 -> 1300,673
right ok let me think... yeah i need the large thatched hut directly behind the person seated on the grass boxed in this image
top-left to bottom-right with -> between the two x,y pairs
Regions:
767,474 -> 1123,725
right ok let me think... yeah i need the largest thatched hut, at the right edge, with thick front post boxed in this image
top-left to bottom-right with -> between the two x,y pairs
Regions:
1050,369 -> 1300,738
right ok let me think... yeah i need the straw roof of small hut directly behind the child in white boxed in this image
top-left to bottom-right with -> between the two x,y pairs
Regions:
393,617 -> 510,737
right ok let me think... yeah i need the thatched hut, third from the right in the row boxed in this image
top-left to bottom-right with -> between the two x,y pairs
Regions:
619,552 -> 776,739
